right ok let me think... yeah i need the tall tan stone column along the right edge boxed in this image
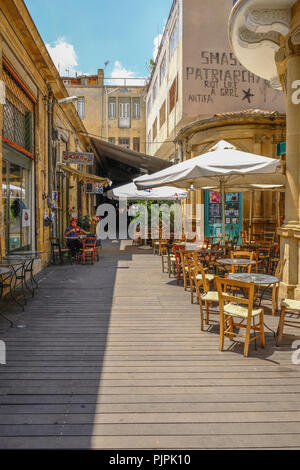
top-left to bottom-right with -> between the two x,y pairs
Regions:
275,1 -> 300,299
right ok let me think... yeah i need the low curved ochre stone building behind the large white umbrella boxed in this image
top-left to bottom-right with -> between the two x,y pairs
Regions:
177,110 -> 286,239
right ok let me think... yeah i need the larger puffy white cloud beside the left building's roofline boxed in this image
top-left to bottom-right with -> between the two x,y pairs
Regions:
46,37 -> 80,77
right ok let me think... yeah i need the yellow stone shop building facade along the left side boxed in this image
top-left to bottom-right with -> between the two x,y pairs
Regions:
0,0 -> 106,265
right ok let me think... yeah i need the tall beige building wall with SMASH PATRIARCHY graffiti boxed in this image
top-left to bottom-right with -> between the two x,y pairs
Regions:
146,0 -> 285,161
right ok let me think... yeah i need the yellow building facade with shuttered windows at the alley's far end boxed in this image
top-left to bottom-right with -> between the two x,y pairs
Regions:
63,69 -> 147,153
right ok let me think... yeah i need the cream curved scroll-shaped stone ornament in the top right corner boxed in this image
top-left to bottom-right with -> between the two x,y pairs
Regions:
228,0 -> 296,90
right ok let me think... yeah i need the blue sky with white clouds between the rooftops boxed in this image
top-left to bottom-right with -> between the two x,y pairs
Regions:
25,0 -> 172,78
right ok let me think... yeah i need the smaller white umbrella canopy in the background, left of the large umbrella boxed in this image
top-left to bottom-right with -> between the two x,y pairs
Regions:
106,183 -> 188,201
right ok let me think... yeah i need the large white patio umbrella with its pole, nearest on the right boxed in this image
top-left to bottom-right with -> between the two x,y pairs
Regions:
134,140 -> 285,241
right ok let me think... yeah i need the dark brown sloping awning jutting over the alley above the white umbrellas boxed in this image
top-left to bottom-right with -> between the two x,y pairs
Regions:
91,138 -> 171,178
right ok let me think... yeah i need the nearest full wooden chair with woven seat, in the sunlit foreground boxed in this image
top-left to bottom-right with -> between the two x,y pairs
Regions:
216,277 -> 265,357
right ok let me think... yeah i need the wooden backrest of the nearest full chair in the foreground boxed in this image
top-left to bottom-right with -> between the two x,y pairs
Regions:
215,277 -> 254,318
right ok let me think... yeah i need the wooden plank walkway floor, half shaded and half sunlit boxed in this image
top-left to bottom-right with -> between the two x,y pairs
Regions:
0,242 -> 300,449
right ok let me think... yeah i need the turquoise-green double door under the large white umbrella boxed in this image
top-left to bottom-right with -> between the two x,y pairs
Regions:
204,191 -> 243,243
